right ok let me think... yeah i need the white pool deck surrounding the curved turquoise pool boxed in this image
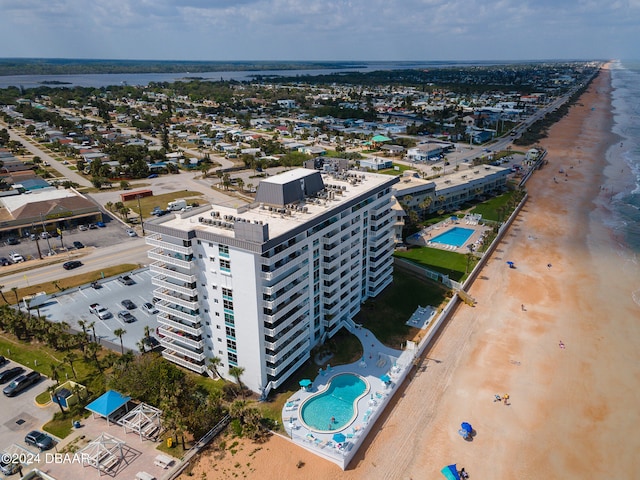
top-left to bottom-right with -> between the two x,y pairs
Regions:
282,325 -> 415,470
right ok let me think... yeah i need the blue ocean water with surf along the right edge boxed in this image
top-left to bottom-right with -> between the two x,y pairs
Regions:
607,61 -> 640,253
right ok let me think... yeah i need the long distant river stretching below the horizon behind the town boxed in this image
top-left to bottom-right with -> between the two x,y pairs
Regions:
0,61 -> 525,89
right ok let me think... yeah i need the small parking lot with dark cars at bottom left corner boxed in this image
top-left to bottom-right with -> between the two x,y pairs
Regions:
0,358 -> 58,453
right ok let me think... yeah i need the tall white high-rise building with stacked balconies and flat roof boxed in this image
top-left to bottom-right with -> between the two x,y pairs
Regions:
145,169 -> 398,394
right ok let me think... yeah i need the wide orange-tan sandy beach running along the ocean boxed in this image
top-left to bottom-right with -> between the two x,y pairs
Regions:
180,64 -> 640,480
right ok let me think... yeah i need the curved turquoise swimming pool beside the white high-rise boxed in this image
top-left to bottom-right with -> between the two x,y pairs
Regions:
300,373 -> 369,432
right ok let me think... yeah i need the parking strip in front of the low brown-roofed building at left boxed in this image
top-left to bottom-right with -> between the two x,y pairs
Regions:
0,220 -> 139,266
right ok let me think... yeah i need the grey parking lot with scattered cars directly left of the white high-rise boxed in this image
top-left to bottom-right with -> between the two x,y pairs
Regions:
38,268 -> 157,352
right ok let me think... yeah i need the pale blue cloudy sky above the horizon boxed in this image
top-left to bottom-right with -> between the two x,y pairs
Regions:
0,0 -> 640,61
